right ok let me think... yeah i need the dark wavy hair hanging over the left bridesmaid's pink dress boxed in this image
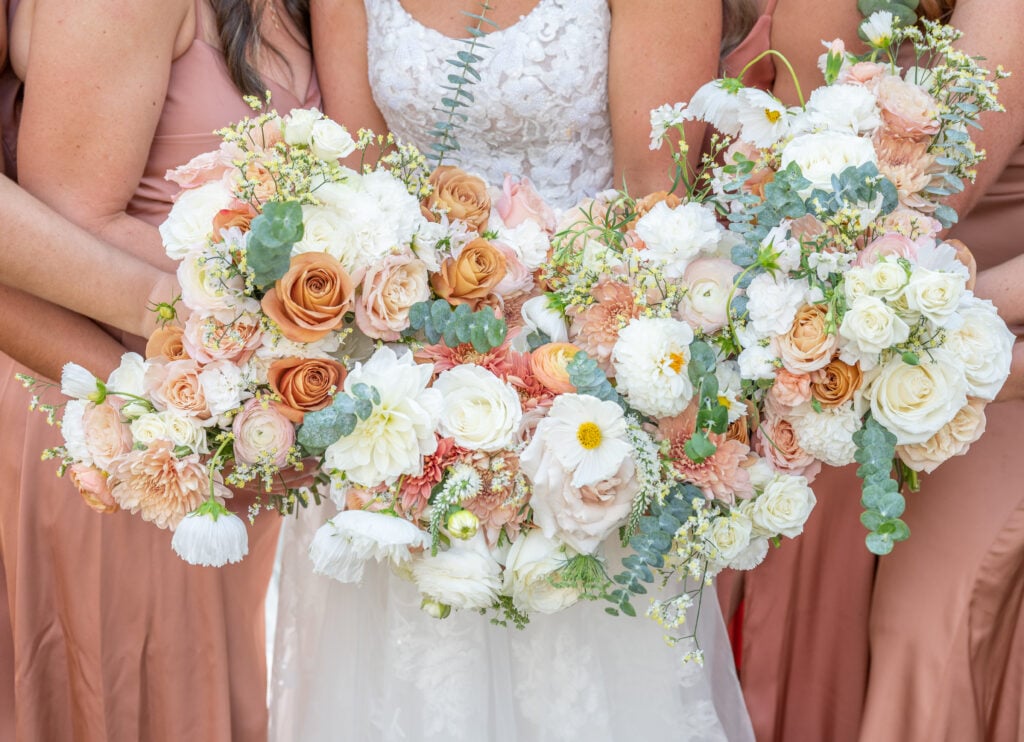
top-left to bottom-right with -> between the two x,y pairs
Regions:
210,0 -> 310,97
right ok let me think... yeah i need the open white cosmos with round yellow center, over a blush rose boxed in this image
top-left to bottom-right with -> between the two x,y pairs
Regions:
530,394 -> 631,487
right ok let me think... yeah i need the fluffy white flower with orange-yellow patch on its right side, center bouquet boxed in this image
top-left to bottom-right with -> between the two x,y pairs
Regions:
611,317 -> 693,418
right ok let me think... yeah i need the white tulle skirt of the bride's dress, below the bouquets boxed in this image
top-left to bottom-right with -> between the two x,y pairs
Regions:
270,506 -> 754,742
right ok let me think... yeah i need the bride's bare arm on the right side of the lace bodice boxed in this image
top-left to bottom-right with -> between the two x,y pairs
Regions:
608,0 -> 722,195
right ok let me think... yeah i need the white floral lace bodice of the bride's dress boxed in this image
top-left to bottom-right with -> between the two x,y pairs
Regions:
366,0 -> 611,208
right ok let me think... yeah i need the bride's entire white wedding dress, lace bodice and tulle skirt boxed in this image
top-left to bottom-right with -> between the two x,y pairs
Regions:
270,0 -> 754,742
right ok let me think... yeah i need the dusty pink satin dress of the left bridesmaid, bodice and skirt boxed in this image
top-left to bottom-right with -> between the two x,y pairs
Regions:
0,2 -> 319,742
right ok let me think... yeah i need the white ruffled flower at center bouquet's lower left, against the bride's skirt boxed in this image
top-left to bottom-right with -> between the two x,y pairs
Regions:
309,510 -> 430,582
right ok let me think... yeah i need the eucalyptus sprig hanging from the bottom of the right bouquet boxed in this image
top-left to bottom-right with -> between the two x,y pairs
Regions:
853,414 -> 910,556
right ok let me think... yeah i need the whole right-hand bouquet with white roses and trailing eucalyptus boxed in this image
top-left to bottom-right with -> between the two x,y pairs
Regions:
677,12 -> 1014,554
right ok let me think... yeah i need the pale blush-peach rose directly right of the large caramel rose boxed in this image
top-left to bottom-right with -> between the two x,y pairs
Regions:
355,255 -> 430,342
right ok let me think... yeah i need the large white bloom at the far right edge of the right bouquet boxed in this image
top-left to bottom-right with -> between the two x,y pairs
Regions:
942,294 -> 1016,400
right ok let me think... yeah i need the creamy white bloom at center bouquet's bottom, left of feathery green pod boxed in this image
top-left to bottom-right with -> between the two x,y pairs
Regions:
504,528 -> 580,613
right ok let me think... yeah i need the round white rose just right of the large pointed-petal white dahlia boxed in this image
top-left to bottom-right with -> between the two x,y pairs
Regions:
433,363 -> 522,451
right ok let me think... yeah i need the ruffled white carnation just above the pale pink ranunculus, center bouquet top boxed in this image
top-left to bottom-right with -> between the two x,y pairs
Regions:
636,201 -> 725,278
